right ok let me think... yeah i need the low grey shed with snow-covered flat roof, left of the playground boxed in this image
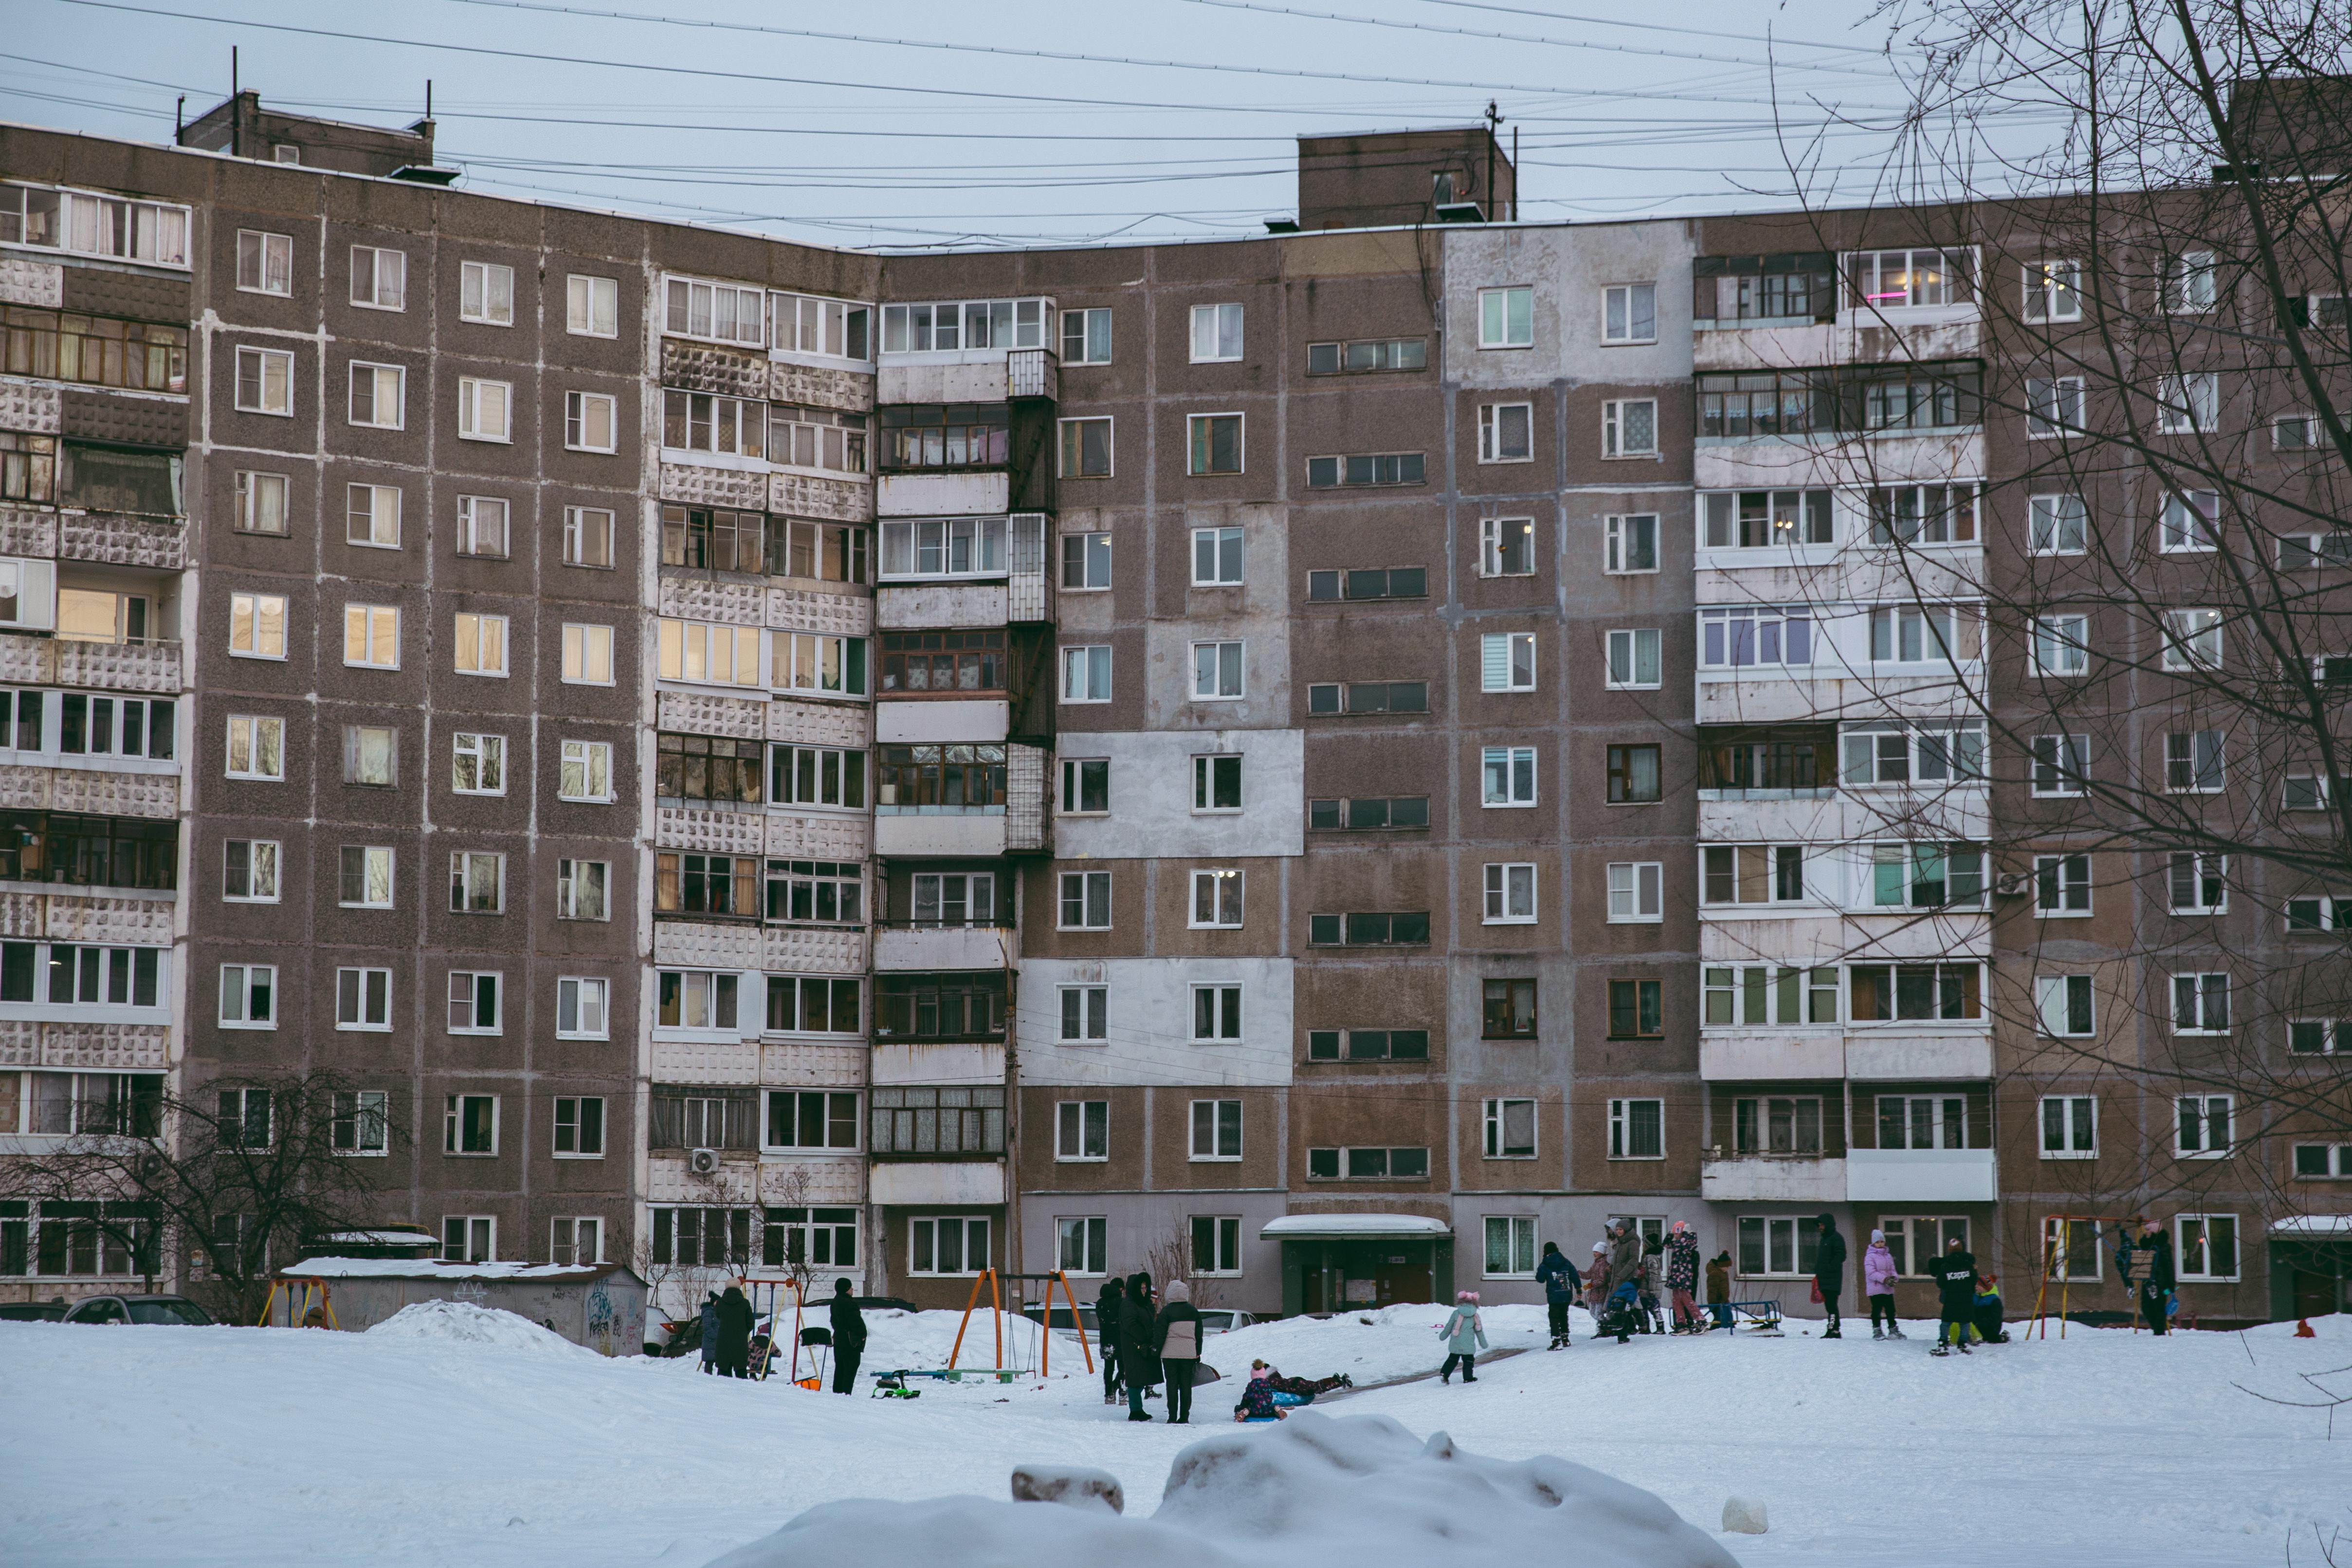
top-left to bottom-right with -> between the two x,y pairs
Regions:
277,1258 -> 644,1356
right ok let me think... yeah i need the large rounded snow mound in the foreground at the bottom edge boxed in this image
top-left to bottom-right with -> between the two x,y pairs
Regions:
712,1413 -> 1738,1568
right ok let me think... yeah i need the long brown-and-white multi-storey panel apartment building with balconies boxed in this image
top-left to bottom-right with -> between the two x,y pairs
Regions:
0,94 -> 2352,1319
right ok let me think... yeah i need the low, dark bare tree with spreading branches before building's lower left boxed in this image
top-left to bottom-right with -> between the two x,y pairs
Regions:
0,1072 -> 407,1324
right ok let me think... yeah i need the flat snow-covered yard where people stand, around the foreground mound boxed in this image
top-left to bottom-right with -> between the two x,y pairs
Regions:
0,1307 -> 2352,1568
